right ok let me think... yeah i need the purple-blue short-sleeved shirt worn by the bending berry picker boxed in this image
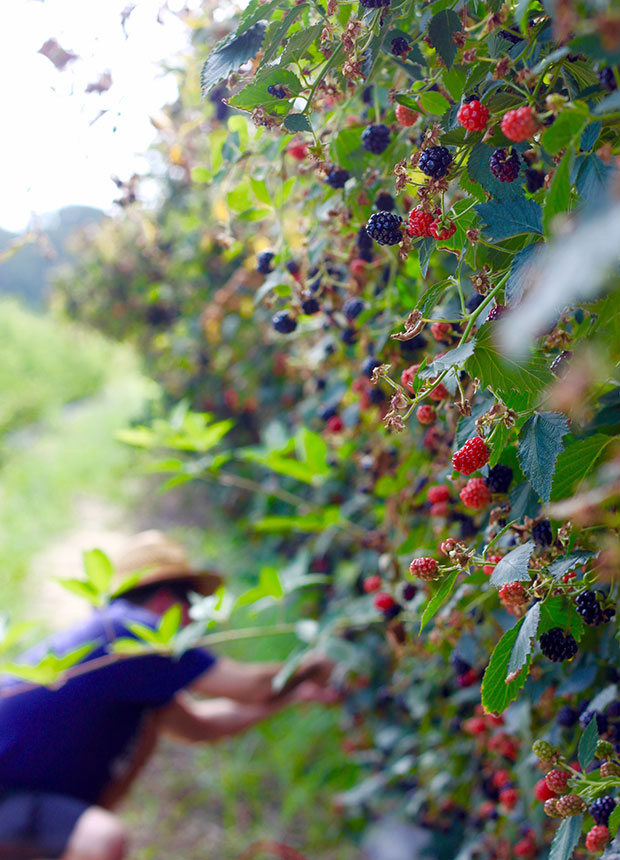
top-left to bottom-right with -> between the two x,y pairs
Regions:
0,600 -> 215,803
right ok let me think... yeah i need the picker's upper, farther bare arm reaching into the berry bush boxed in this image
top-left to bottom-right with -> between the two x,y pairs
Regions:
190,654 -> 334,705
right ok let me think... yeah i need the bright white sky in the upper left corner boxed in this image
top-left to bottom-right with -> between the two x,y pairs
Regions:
0,0 -> 208,232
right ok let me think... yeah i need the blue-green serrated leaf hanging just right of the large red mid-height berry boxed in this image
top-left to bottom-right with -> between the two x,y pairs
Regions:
518,412 -> 569,502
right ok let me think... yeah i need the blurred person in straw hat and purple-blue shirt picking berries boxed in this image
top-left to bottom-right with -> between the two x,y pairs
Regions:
0,531 -> 337,860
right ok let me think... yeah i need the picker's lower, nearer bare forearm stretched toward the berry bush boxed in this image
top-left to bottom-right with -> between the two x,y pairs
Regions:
159,682 -> 337,743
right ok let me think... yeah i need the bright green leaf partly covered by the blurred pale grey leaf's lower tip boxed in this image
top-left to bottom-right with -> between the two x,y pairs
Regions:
465,322 -> 551,408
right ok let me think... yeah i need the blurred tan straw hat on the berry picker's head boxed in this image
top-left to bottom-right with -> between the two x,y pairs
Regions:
116,529 -> 222,596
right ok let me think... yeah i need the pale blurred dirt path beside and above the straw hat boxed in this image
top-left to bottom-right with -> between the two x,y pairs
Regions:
28,496 -> 132,629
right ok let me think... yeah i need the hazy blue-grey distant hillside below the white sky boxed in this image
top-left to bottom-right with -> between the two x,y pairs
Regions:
0,206 -> 105,308
